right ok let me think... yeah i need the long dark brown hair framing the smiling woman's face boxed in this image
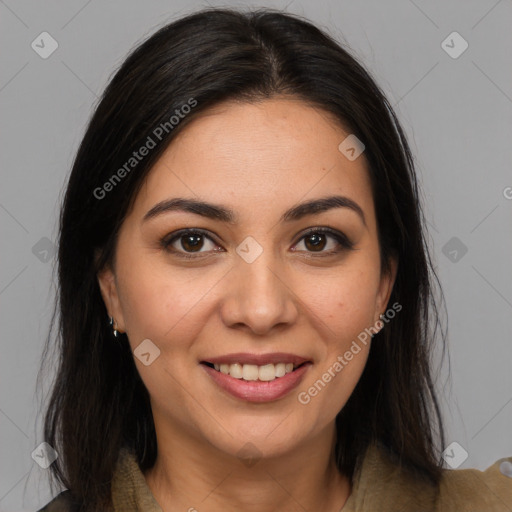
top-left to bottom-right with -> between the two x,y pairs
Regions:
40,9 -> 445,510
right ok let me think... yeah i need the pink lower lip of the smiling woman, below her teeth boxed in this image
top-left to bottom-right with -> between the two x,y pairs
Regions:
201,363 -> 311,402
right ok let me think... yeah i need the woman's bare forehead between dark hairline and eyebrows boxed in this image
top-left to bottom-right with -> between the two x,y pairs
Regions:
130,98 -> 373,224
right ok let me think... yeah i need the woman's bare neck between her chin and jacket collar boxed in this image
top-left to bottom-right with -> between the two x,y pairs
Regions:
144,423 -> 351,512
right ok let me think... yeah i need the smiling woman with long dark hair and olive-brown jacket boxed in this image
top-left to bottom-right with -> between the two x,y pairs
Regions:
37,6 -> 512,512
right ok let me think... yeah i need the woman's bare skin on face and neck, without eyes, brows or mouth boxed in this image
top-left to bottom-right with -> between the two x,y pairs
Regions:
98,97 -> 396,512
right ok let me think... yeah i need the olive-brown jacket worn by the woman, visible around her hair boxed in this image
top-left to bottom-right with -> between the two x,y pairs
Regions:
38,445 -> 512,512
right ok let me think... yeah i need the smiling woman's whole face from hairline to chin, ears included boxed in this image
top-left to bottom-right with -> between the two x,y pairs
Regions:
99,98 -> 395,457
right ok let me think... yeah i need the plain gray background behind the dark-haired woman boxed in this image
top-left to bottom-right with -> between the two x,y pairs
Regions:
0,0 -> 512,511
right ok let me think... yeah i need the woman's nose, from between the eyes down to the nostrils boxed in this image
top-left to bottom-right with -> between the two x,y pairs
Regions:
221,251 -> 299,336
